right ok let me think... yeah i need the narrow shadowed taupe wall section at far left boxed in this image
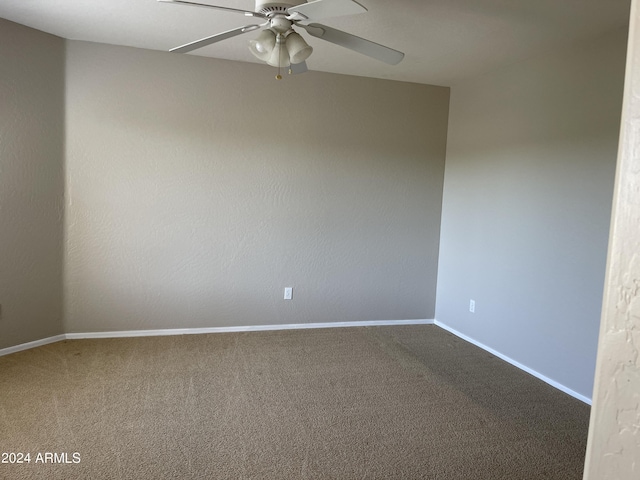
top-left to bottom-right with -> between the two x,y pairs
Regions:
0,19 -> 64,348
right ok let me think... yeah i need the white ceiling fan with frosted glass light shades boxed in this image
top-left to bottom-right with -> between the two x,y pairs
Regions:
158,0 -> 404,79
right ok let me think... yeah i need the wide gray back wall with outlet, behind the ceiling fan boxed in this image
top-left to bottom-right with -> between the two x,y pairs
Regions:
65,41 -> 449,332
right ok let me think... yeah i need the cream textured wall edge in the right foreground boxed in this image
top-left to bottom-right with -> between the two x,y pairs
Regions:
584,1 -> 640,480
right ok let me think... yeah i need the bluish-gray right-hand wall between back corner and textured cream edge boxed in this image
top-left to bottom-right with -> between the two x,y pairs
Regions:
436,31 -> 626,397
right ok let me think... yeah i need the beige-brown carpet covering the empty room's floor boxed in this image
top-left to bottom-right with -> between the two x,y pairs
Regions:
0,326 -> 589,480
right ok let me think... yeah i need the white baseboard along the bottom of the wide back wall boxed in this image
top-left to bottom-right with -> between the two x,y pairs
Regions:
65,320 -> 434,340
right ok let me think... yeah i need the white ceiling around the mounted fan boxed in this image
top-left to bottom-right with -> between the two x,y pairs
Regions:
0,0 -> 630,85
